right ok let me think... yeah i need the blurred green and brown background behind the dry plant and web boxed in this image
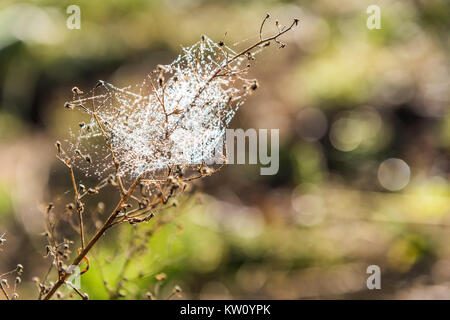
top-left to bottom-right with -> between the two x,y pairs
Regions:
0,0 -> 450,299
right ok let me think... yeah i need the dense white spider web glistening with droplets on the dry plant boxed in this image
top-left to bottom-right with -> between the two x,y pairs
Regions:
68,36 -> 254,180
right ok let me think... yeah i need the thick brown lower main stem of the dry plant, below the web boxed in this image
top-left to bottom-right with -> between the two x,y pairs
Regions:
44,175 -> 142,300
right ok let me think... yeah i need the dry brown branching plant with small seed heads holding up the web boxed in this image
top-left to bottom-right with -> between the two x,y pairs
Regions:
40,15 -> 298,300
